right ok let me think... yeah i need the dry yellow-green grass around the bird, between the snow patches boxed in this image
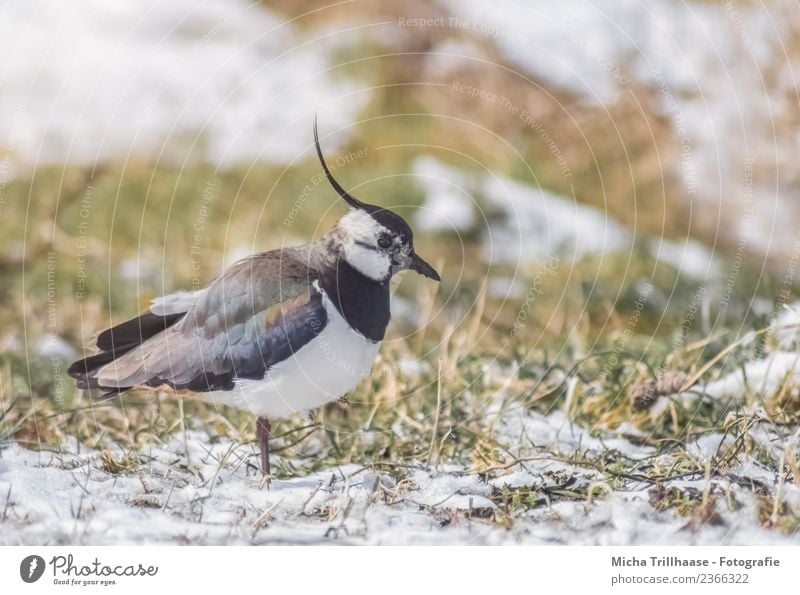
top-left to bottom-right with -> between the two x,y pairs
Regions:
0,3 -> 800,532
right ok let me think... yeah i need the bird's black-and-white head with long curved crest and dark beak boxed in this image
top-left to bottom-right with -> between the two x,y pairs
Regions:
314,119 -> 441,281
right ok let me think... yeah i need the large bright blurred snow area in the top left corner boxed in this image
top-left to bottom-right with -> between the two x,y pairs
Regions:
0,0 -> 367,175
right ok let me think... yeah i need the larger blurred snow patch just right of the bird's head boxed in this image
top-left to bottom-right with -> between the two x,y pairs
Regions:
413,156 -> 632,263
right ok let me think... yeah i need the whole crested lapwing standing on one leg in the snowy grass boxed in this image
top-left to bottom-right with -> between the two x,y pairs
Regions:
68,117 -> 441,479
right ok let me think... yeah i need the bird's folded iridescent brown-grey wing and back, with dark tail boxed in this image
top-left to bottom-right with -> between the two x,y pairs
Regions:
69,250 -> 327,395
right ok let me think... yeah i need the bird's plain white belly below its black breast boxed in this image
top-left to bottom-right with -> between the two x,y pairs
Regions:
205,295 -> 378,417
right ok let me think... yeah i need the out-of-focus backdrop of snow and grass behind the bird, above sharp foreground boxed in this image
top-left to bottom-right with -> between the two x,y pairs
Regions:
0,0 -> 800,452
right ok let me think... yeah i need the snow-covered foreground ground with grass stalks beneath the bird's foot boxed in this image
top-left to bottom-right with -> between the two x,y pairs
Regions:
0,409 -> 800,545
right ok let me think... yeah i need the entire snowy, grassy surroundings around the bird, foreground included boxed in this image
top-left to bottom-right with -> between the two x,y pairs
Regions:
0,0 -> 800,544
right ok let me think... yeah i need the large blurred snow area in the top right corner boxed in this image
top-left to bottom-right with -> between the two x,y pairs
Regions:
448,0 -> 800,253
